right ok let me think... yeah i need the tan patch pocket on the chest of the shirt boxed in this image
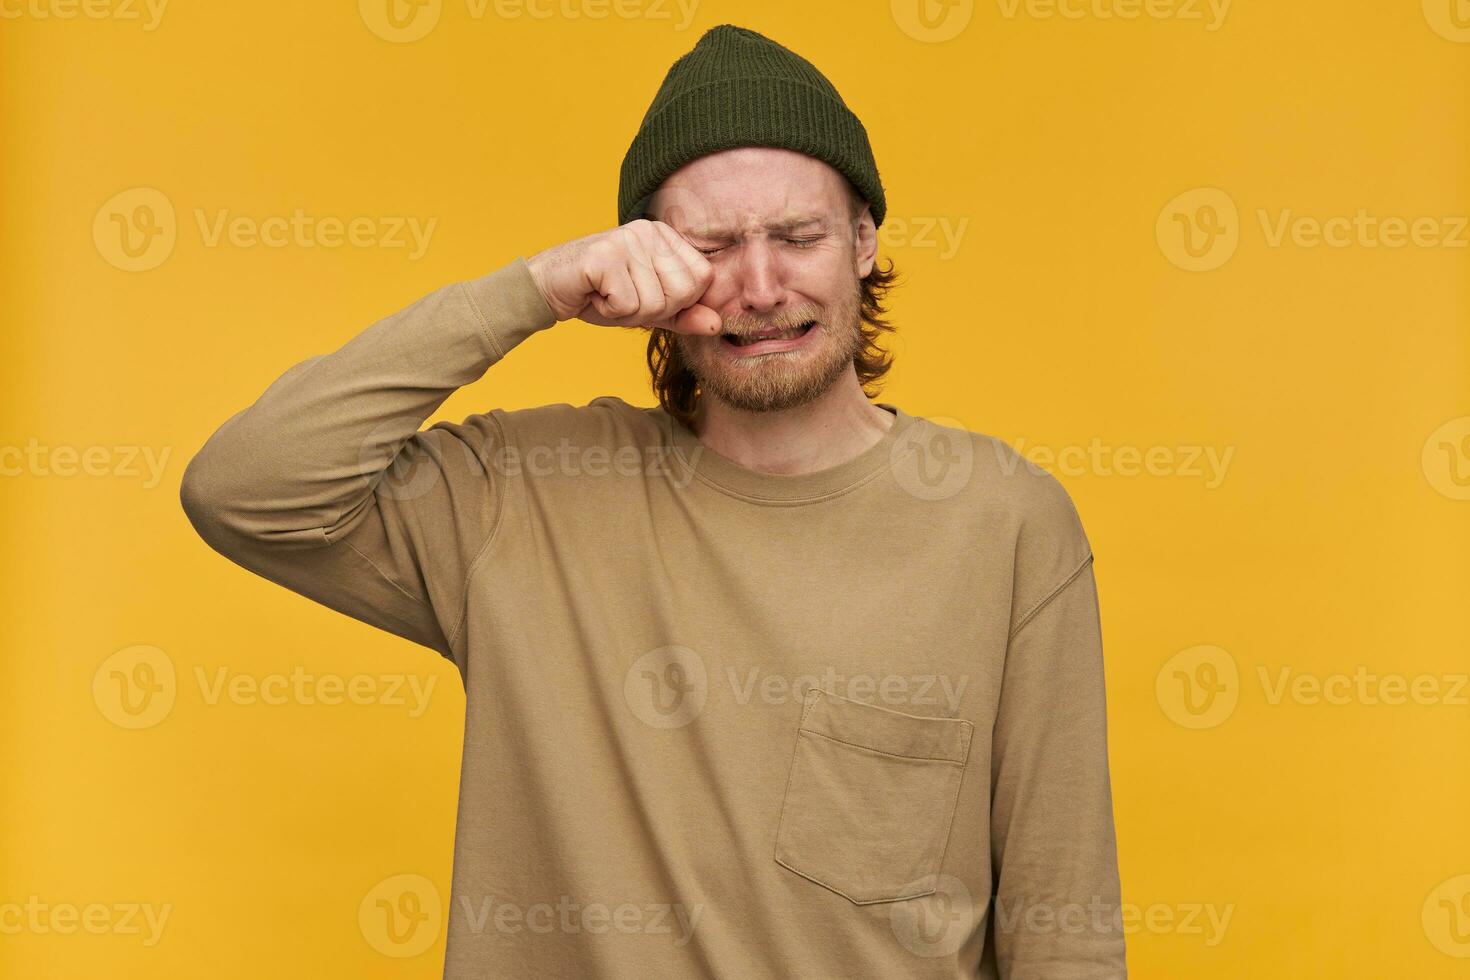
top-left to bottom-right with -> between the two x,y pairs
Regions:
776,689 -> 975,905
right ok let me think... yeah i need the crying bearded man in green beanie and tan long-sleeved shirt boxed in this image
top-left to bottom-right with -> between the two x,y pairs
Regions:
182,25 -> 1126,980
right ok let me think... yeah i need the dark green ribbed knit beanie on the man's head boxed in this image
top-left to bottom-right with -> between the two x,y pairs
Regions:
617,24 -> 886,225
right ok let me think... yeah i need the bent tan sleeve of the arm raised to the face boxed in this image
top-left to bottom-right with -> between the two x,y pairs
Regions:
179,257 -> 556,670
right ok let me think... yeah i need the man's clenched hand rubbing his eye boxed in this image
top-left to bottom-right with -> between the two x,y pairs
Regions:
526,219 -> 722,336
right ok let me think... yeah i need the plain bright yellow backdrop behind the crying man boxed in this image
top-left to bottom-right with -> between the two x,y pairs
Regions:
0,0 -> 1470,979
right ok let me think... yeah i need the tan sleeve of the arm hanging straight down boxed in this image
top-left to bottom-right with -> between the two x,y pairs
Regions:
988,554 -> 1127,980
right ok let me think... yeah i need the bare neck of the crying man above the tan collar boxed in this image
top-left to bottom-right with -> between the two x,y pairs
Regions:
691,375 -> 894,475
